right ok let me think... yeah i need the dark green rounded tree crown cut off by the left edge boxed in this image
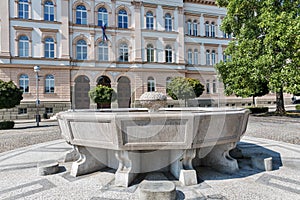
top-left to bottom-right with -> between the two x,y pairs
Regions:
0,80 -> 23,109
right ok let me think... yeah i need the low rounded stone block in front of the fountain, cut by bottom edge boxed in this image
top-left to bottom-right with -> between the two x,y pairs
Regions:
139,181 -> 176,200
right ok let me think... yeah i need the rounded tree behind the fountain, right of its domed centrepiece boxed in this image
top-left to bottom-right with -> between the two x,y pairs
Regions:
167,77 -> 204,106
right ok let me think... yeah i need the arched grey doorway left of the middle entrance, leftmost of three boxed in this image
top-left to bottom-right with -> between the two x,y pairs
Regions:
75,75 -> 90,109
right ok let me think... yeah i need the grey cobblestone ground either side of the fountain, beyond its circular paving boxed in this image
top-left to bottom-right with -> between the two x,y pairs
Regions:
0,116 -> 300,153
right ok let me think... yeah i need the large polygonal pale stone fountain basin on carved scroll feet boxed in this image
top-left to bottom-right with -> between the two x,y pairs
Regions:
58,92 -> 249,187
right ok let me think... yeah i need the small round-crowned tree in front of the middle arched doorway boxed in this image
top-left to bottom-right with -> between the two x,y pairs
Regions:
89,85 -> 116,108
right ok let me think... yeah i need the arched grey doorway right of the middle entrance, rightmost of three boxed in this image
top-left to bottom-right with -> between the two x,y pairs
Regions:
117,76 -> 131,108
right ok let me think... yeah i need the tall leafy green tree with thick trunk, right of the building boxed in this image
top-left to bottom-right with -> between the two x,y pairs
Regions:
216,0 -> 300,113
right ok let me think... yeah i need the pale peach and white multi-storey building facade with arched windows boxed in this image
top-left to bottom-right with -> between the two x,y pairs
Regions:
0,0 -> 282,119
